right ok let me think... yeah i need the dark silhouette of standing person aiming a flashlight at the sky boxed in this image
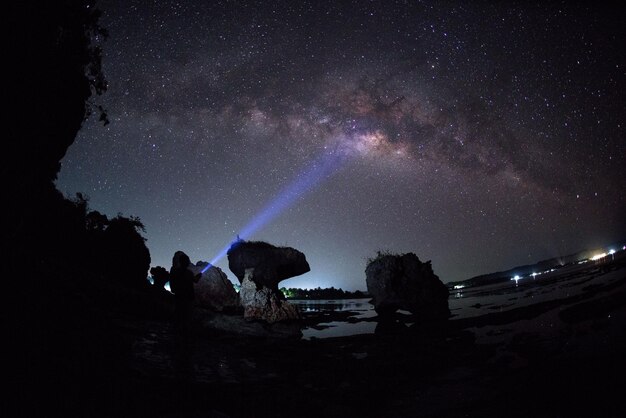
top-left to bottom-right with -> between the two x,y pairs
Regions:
170,251 -> 202,331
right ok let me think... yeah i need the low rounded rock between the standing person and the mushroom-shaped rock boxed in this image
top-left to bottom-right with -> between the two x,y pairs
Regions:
188,261 -> 240,312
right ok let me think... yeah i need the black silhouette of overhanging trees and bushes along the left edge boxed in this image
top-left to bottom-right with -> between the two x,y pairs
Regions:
7,0 -> 155,295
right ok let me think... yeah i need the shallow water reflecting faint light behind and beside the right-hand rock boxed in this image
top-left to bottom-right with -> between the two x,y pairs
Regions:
290,266 -> 624,339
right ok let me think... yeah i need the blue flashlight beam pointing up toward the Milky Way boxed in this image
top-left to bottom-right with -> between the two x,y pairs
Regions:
202,152 -> 347,273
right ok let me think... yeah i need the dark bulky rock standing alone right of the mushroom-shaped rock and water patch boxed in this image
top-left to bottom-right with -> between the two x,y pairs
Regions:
365,253 -> 450,321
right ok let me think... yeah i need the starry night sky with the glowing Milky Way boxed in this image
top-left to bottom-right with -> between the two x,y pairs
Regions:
57,0 -> 626,290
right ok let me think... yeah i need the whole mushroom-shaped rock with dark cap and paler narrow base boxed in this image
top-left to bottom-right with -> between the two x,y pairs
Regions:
228,240 -> 310,323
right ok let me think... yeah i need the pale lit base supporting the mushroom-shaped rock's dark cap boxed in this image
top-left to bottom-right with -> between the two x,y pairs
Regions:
239,268 -> 300,324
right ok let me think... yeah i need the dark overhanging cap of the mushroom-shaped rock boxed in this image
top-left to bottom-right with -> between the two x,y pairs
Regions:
227,240 -> 311,294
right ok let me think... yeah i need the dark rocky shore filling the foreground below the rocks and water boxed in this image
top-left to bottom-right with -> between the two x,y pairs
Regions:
15,265 -> 626,417
